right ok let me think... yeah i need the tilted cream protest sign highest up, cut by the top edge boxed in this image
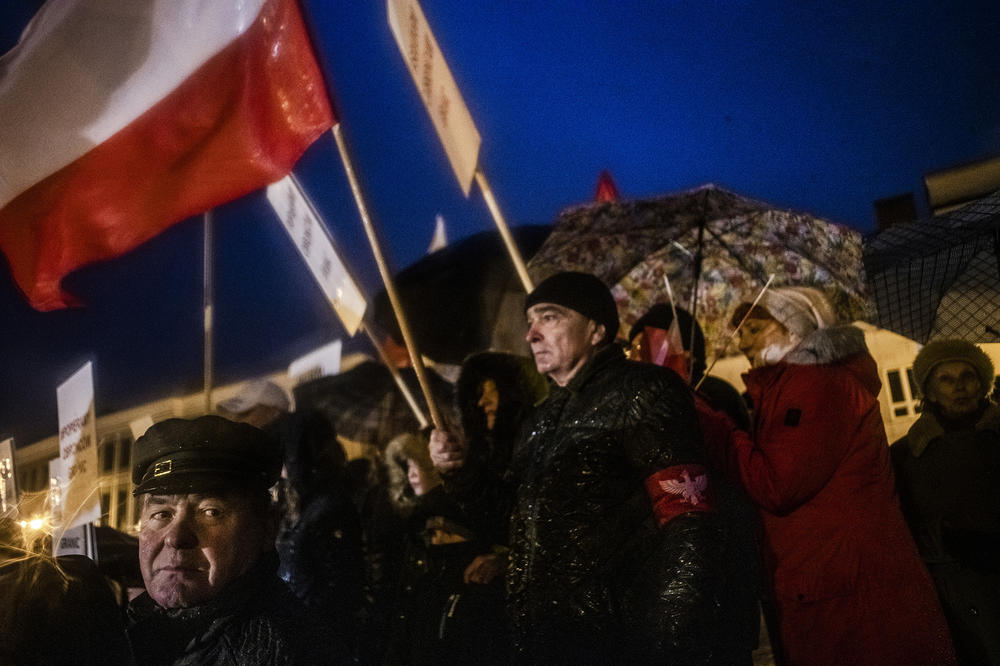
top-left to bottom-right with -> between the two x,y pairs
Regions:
386,0 -> 481,196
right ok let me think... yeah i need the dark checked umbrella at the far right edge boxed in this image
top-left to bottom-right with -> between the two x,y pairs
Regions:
864,192 -> 1000,343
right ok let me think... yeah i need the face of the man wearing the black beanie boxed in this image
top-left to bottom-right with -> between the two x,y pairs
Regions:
525,303 -> 604,386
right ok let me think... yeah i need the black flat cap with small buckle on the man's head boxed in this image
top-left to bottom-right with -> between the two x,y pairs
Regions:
132,416 -> 281,495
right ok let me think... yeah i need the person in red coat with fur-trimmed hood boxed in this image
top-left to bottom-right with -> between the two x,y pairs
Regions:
708,287 -> 955,666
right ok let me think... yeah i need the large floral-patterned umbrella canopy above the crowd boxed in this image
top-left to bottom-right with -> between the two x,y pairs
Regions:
528,185 -> 873,353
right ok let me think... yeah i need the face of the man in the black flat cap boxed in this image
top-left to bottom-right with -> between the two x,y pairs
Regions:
139,493 -> 273,608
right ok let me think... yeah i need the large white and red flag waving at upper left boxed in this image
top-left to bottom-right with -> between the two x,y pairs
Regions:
0,0 -> 335,310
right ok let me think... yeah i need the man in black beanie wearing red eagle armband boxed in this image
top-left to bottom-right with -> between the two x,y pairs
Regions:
431,272 -> 723,664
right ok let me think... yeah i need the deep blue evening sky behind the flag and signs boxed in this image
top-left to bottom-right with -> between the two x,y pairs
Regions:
0,0 -> 1000,443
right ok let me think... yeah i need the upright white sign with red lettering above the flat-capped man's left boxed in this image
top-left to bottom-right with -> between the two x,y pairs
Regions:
56,361 -> 101,529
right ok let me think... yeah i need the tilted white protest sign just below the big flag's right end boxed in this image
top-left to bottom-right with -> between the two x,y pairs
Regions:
267,175 -> 367,335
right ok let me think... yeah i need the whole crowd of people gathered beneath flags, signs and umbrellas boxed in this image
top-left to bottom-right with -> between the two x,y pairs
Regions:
0,272 -> 1000,666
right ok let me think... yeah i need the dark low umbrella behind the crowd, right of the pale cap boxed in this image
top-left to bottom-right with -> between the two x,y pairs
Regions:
294,361 -> 453,450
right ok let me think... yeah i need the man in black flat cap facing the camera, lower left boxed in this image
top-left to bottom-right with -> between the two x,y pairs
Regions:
128,416 -> 346,665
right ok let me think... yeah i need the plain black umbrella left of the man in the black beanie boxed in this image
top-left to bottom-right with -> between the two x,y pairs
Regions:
372,225 -> 551,364
